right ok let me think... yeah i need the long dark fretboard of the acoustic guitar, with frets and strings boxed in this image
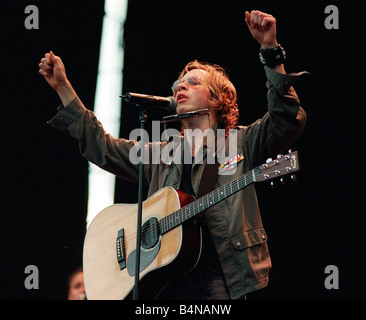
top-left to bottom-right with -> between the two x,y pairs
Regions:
159,167 -> 260,234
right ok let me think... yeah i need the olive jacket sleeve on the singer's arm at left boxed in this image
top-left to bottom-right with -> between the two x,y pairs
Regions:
47,97 -> 150,183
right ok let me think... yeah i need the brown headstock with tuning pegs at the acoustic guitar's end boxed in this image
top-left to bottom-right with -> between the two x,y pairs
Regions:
255,151 -> 300,182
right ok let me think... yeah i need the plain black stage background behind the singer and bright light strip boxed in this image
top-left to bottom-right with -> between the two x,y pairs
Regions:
0,0 -> 366,300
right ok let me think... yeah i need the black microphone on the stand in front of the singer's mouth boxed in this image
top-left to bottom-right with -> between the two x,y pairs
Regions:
120,92 -> 177,111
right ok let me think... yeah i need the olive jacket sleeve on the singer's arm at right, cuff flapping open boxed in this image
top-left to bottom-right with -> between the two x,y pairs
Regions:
243,67 -> 308,168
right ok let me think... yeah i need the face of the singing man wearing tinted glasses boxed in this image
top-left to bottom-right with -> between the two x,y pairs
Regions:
174,69 -> 210,114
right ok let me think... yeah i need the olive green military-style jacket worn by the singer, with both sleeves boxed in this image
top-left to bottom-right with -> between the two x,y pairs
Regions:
48,67 -> 306,299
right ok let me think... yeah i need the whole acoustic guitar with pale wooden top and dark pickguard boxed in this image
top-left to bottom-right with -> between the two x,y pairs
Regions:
83,151 -> 299,300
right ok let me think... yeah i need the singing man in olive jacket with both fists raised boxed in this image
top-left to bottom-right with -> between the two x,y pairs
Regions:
39,11 -> 306,300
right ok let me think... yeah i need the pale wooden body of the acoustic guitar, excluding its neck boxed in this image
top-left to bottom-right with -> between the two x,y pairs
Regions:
83,187 -> 201,300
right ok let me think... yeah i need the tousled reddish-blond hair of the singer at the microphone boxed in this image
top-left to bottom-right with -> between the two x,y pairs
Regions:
178,60 -> 239,135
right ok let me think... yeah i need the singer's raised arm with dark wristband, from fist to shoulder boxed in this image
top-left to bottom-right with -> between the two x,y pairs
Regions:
245,10 -> 307,166
